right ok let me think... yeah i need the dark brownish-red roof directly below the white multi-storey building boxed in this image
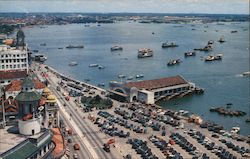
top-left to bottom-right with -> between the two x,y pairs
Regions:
0,71 -> 27,80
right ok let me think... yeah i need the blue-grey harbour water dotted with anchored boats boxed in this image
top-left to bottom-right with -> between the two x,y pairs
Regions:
23,21 -> 250,135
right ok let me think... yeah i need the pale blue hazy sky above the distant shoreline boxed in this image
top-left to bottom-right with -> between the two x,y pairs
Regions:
0,0 -> 250,14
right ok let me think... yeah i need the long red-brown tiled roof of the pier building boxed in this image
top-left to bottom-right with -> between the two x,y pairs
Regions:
124,76 -> 188,90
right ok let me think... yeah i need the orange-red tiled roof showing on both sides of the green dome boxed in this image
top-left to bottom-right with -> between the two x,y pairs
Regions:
5,80 -> 46,91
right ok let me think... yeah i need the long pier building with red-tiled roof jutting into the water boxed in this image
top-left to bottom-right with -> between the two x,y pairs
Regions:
109,76 -> 195,104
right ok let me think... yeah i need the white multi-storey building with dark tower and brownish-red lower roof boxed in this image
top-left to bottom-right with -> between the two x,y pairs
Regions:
0,30 -> 29,85
